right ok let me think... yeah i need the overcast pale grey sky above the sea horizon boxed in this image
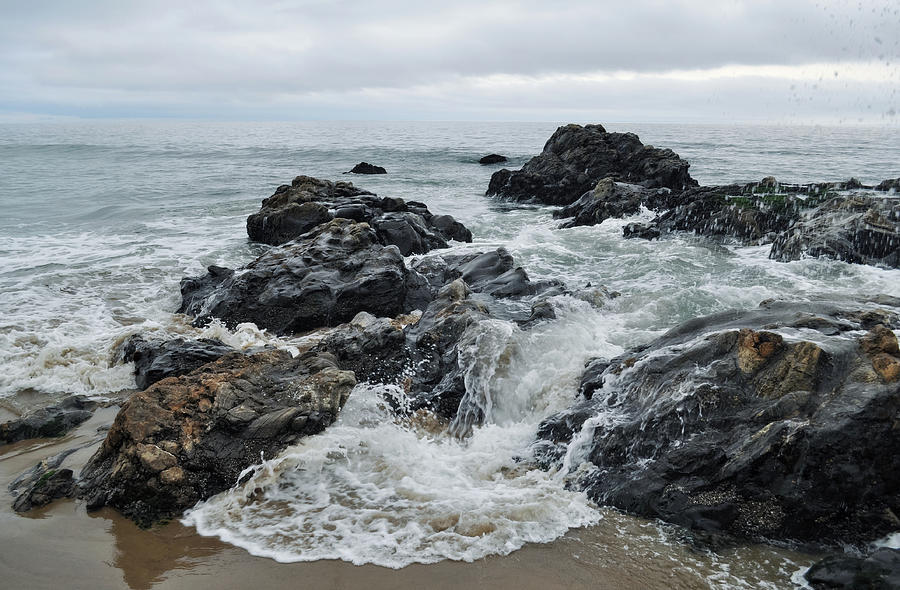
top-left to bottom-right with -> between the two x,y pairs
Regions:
0,0 -> 900,125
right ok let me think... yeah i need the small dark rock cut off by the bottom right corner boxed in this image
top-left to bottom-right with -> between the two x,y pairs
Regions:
803,547 -> 900,590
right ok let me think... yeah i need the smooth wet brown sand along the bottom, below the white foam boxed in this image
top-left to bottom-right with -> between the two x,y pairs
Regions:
0,408 -> 815,590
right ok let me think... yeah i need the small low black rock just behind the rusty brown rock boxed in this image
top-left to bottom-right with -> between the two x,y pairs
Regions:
123,334 -> 234,389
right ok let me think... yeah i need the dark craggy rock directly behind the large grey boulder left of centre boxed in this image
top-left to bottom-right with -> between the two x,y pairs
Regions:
247,176 -> 472,256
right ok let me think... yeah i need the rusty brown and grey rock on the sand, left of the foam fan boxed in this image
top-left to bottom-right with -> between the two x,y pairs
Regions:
78,350 -> 356,525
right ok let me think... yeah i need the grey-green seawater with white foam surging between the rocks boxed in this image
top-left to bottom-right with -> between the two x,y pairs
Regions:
0,121 -> 900,587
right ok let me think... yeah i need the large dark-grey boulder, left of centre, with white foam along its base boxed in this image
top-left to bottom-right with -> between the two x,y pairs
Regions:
178,219 -> 427,334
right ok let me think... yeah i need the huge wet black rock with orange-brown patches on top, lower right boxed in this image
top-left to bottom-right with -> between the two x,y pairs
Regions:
536,300 -> 900,545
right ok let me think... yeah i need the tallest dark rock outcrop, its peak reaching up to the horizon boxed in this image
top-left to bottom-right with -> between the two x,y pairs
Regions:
487,125 -> 697,205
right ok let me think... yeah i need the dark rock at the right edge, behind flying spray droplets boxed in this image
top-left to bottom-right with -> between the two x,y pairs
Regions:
769,195 -> 900,268
